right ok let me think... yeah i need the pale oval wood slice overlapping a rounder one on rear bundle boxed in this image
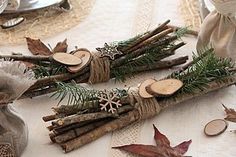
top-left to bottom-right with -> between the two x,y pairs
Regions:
52,53 -> 82,66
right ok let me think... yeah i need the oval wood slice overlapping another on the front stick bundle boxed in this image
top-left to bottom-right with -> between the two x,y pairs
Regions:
146,79 -> 183,96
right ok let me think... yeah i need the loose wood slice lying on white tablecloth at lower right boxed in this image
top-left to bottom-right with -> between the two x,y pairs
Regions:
204,119 -> 228,136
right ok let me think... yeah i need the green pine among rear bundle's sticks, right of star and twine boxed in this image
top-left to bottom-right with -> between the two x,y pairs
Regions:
111,27 -> 188,82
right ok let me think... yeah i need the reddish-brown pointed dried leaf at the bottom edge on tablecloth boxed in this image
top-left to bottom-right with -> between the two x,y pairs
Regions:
113,125 -> 192,157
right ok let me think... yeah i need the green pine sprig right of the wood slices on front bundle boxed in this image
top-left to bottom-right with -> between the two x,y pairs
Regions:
170,48 -> 234,94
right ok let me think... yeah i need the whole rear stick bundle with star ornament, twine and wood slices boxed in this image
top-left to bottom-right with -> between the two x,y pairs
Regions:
0,20 -> 197,98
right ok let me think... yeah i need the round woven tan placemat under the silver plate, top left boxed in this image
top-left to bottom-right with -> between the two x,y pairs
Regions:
0,0 -> 95,45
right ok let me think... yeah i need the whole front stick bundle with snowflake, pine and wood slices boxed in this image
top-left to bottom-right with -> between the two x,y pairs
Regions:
43,48 -> 236,153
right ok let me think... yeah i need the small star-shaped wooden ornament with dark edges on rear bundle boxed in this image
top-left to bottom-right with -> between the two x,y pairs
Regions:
96,43 -> 123,60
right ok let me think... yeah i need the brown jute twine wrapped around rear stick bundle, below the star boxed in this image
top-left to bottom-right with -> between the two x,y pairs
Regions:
89,54 -> 111,84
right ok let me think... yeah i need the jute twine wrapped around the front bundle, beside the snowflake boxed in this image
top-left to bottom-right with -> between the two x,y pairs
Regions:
129,89 -> 161,120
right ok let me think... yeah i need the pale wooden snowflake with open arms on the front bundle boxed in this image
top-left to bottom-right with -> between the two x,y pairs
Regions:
98,90 -> 122,113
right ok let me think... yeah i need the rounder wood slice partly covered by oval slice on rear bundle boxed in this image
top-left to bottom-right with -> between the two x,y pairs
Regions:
67,50 -> 92,73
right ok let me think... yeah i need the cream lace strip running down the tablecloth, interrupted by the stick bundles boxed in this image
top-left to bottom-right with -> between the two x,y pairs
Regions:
109,0 -> 155,157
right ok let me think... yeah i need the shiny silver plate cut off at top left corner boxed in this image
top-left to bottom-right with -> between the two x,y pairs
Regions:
4,0 -> 64,13
